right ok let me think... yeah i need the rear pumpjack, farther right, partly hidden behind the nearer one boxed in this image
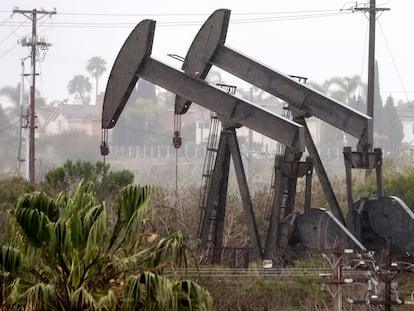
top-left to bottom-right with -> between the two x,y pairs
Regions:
176,9 -> 414,259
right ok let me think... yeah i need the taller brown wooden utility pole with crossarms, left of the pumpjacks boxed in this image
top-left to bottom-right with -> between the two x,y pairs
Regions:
13,9 -> 56,183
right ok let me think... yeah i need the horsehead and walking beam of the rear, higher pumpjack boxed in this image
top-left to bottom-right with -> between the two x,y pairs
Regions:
175,9 -> 372,144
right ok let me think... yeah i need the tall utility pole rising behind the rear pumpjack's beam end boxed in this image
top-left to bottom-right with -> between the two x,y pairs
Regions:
354,0 -> 390,153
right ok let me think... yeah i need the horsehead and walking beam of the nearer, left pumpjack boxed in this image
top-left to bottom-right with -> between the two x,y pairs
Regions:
102,20 -> 305,152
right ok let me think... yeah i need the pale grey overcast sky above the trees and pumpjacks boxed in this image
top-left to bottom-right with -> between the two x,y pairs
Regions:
0,0 -> 414,103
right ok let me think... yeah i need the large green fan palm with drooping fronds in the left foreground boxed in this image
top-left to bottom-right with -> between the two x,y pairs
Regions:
0,182 -> 212,311
